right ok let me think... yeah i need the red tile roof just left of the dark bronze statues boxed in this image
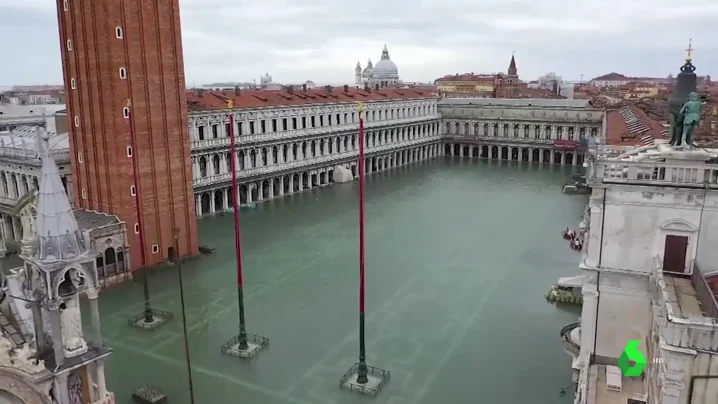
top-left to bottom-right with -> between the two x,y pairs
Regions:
606,105 -> 667,146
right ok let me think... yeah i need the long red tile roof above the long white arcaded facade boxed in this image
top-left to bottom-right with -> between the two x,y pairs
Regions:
187,87 -> 436,111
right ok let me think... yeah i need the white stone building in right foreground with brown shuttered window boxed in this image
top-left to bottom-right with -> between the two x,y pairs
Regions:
562,143 -> 718,404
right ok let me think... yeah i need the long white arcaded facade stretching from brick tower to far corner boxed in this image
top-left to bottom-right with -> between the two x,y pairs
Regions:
189,98 -> 441,216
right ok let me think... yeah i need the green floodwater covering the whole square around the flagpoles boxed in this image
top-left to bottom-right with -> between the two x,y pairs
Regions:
29,158 -> 586,404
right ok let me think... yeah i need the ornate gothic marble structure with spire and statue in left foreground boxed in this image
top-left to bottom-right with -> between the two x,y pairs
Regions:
0,132 -> 115,404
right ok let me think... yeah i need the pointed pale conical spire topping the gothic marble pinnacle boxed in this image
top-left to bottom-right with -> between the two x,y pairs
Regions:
34,127 -> 86,264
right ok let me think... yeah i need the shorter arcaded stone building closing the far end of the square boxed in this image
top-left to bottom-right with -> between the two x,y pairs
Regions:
438,98 -> 606,165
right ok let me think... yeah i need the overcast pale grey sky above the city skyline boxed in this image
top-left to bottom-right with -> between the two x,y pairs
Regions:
0,0 -> 718,86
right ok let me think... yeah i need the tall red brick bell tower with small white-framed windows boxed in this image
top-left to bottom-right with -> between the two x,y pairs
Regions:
57,0 -> 198,270
